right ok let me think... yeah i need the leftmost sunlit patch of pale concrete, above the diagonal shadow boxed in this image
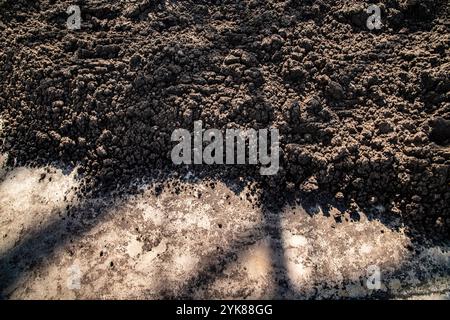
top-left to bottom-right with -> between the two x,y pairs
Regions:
0,167 -> 77,253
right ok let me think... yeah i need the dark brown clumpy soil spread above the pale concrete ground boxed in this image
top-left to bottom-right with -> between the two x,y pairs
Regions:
0,0 -> 450,234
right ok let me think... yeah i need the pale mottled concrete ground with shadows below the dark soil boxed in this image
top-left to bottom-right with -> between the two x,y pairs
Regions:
0,161 -> 450,299
